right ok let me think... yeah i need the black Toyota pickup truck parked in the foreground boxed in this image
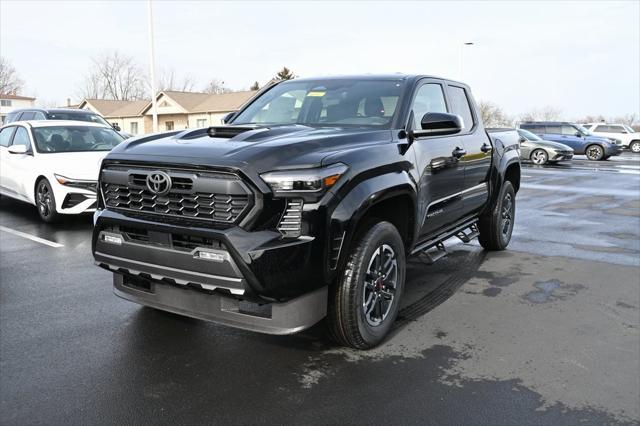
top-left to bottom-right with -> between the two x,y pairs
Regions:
92,75 -> 520,348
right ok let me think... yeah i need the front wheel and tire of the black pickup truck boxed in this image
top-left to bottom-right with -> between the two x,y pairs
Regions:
327,222 -> 406,349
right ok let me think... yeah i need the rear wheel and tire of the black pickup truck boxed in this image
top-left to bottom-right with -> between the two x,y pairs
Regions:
478,180 -> 516,250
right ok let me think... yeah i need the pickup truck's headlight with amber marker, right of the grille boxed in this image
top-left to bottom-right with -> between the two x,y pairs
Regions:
260,163 -> 348,196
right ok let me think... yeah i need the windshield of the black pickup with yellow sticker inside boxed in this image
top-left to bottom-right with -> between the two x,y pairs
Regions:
232,79 -> 403,128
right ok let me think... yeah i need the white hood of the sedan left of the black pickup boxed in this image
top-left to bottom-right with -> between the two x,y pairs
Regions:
39,151 -> 109,180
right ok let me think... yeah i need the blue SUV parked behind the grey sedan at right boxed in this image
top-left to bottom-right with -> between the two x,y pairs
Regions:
518,121 -> 622,161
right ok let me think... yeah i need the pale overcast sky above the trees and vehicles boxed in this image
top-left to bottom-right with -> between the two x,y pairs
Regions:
0,0 -> 640,119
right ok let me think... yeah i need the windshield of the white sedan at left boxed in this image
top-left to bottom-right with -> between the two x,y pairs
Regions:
33,126 -> 124,154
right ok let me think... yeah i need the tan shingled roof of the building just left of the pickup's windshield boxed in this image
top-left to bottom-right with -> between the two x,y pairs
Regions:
141,90 -> 257,114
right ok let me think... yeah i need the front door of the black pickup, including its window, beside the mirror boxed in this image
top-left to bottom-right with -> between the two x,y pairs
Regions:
409,79 -> 464,240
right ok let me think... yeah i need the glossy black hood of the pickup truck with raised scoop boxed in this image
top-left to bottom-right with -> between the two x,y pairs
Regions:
109,125 -> 391,173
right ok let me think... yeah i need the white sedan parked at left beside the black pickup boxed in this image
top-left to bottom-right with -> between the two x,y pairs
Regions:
0,120 -> 124,222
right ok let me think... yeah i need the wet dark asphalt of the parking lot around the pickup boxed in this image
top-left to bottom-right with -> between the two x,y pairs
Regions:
0,153 -> 640,425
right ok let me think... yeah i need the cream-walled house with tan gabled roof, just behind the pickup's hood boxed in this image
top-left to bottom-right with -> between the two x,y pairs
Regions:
142,90 -> 257,132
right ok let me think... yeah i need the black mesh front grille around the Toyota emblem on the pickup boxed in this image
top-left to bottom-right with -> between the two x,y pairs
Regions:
101,166 -> 253,224
